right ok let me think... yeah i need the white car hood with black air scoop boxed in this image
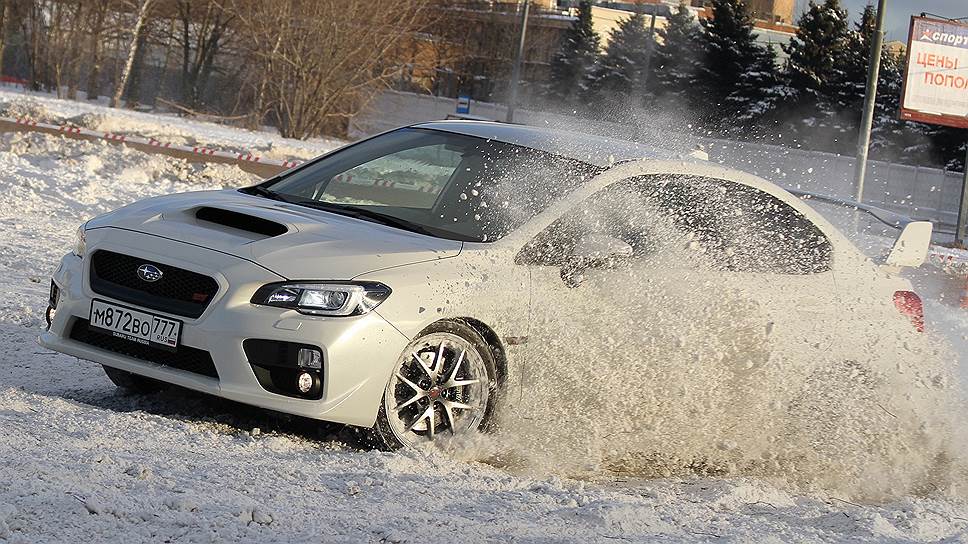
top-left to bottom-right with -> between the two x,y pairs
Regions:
87,189 -> 462,280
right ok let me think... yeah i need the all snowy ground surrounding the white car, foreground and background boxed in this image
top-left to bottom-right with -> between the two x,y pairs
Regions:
0,92 -> 968,543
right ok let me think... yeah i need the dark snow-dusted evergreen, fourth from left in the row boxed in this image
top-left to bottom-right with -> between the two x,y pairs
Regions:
698,0 -> 776,131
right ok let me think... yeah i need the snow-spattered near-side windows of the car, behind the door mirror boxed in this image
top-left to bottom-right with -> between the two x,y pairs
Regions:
517,176 -> 831,274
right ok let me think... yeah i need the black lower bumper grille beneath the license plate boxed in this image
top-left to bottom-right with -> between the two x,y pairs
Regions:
70,319 -> 218,379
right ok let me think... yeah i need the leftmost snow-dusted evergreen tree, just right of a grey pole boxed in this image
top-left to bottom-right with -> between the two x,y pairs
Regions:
546,0 -> 600,103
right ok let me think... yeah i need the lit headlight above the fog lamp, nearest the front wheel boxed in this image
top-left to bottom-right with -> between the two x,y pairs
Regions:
252,282 -> 390,316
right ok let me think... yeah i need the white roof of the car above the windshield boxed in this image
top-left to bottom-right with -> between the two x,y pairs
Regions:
412,120 -> 687,167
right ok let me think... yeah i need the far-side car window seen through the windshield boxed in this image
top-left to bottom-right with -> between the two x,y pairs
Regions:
313,144 -> 462,209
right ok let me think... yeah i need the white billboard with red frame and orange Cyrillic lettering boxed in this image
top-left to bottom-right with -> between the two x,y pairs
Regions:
901,17 -> 968,128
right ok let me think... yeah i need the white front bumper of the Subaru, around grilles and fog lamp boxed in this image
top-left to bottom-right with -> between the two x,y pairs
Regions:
40,228 -> 409,427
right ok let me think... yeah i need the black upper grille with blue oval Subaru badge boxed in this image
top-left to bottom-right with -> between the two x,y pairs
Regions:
91,249 -> 218,318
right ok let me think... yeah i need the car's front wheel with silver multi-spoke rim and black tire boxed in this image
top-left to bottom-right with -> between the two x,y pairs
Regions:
369,321 -> 499,451
